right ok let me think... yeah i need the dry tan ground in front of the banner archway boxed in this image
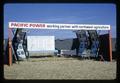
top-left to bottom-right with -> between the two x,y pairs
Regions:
4,57 -> 116,80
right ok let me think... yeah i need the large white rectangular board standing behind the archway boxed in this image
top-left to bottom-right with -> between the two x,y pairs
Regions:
27,36 -> 55,51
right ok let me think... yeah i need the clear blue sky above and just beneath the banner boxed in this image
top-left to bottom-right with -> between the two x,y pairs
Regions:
4,3 -> 116,39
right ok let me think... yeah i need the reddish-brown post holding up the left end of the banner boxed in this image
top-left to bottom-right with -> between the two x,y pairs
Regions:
8,28 -> 12,66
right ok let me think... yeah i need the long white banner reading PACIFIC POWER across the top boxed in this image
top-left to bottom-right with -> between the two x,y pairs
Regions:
9,22 -> 110,30
